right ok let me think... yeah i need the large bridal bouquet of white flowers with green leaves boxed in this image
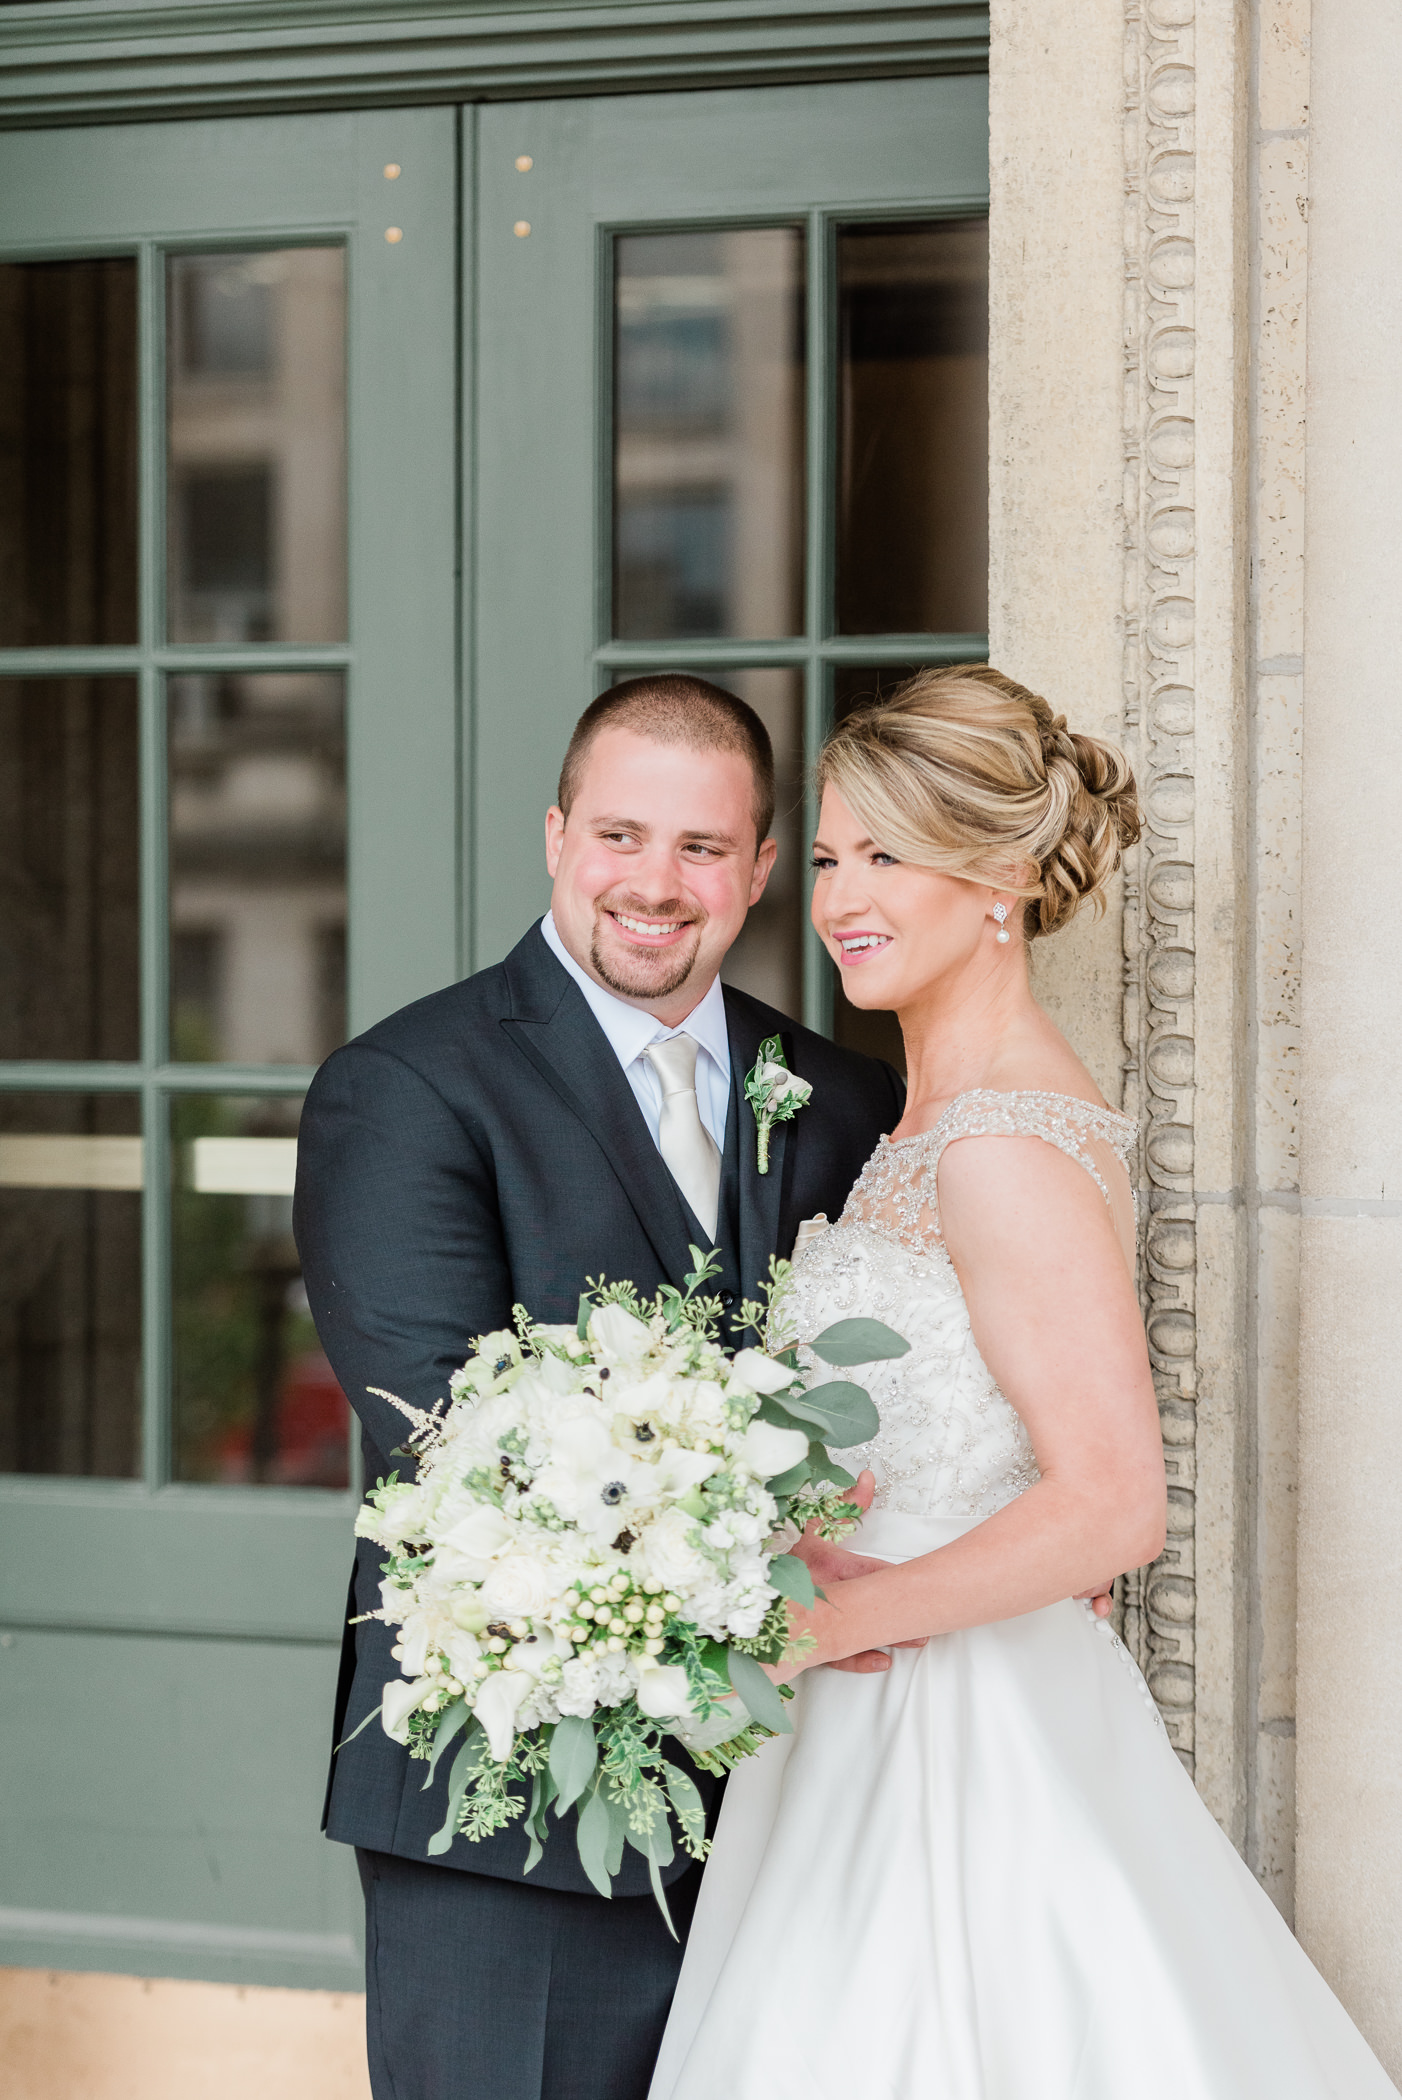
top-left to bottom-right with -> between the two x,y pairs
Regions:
344,1247 -> 907,1913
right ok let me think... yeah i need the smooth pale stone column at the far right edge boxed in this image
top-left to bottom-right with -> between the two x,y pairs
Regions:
1297,0 -> 1402,2077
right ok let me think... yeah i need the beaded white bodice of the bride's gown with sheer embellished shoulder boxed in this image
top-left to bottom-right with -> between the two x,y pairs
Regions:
785,1090 -> 1135,1516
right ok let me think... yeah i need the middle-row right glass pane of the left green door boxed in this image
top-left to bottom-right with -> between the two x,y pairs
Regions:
170,672 -> 346,1065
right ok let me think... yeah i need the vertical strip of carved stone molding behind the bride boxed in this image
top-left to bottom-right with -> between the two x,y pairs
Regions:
1121,0 -> 1198,1768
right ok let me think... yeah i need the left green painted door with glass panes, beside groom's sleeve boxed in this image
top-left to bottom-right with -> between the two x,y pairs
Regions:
0,109 -> 460,1989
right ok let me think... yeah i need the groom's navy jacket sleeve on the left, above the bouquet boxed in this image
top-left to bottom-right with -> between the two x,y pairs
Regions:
294,1044 -> 512,1457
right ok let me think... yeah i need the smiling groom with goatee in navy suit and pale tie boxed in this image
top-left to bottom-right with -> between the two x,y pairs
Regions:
296,676 -> 902,2100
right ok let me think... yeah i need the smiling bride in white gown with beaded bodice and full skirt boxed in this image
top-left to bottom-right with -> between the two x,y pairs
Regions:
651,668 -> 1394,2100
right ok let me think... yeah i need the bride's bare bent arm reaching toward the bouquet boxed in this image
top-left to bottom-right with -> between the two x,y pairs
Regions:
774,1136 -> 1167,1676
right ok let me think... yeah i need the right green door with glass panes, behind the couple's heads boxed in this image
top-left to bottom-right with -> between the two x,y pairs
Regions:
470,76 -> 989,1048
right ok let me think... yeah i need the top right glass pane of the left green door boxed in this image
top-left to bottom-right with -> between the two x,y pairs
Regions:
166,248 -> 346,643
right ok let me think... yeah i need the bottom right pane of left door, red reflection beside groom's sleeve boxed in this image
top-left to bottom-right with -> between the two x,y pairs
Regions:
172,1094 -> 351,1487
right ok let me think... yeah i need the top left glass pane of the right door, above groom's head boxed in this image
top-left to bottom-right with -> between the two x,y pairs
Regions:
613,227 -> 804,641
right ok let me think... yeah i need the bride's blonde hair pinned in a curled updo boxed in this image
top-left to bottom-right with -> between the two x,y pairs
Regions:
819,664 -> 1140,941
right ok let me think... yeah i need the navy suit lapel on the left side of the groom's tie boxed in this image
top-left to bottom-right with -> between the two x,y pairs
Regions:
502,928 -> 693,1285
